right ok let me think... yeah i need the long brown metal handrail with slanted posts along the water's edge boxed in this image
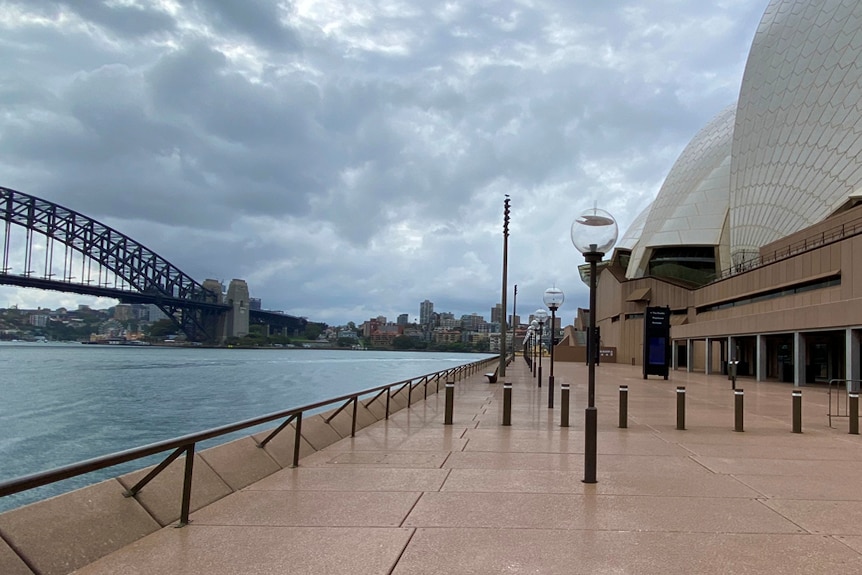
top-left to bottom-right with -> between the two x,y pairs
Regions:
0,357 -> 499,526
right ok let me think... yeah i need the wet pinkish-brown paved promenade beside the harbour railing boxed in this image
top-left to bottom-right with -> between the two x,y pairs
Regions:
72,358 -> 862,575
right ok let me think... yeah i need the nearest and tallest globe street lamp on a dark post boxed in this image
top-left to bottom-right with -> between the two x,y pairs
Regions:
571,207 -> 617,483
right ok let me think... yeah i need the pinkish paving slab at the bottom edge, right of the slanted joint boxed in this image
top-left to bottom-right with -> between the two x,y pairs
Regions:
393,528 -> 862,575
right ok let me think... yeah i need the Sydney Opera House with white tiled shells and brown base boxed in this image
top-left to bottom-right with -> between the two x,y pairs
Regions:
596,0 -> 862,385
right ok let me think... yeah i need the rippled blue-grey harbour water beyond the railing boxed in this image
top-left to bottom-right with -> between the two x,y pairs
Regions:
0,343 -> 486,511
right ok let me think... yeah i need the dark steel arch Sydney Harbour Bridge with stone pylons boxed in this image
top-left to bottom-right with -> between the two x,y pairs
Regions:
0,187 -> 307,343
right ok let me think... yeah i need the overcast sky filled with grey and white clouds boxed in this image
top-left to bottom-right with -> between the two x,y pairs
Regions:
0,0 -> 768,325
